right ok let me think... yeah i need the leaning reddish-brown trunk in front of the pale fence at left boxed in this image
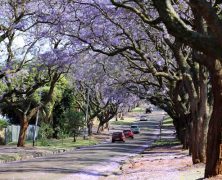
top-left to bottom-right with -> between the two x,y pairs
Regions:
17,116 -> 29,147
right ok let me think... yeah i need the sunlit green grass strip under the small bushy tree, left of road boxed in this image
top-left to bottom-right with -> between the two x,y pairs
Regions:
9,137 -> 98,150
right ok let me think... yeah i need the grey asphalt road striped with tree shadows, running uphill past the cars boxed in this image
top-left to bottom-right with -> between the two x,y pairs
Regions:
0,112 -> 163,180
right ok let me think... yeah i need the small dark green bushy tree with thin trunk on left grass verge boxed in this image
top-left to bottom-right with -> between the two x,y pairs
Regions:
65,109 -> 85,142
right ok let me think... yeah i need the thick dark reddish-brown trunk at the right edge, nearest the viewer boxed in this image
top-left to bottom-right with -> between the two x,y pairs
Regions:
205,64 -> 222,178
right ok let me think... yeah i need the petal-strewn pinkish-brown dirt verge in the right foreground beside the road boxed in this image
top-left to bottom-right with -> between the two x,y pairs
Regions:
105,146 -> 204,180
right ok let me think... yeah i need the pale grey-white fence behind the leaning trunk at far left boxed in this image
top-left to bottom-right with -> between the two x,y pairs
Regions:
0,125 -> 39,144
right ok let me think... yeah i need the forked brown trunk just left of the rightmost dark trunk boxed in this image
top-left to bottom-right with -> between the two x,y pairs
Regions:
184,72 -> 207,164
